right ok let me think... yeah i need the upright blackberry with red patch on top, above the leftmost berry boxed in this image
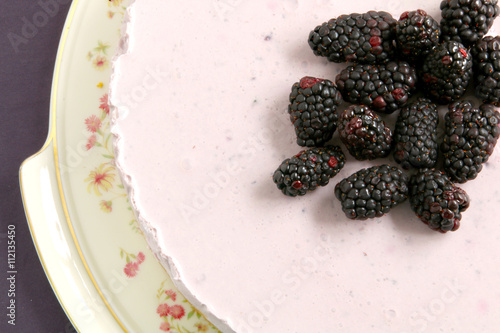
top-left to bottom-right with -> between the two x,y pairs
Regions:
288,76 -> 342,147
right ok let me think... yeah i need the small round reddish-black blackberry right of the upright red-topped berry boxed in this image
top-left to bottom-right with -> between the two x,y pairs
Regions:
338,105 -> 392,160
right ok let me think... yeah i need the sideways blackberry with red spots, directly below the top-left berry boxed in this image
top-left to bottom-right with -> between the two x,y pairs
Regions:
336,61 -> 417,113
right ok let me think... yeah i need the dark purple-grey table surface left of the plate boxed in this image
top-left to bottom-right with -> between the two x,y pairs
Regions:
0,0 -> 75,333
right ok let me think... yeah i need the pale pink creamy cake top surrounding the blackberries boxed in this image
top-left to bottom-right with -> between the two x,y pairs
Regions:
110,0 -> 500,333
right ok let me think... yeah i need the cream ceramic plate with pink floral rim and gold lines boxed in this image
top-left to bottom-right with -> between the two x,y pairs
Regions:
21,0 -> 217,333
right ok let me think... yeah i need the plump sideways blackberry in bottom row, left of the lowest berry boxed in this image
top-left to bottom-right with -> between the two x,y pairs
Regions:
335,165 -> 408,220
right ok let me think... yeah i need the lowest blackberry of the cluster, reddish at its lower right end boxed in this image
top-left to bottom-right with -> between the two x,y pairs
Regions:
409,168 -> 470,233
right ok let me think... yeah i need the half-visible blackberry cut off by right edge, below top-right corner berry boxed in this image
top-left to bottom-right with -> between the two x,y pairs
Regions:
472,36 -> 500,106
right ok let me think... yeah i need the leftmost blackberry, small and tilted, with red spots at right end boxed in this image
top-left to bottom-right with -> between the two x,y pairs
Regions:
273,146 -> 345,197
